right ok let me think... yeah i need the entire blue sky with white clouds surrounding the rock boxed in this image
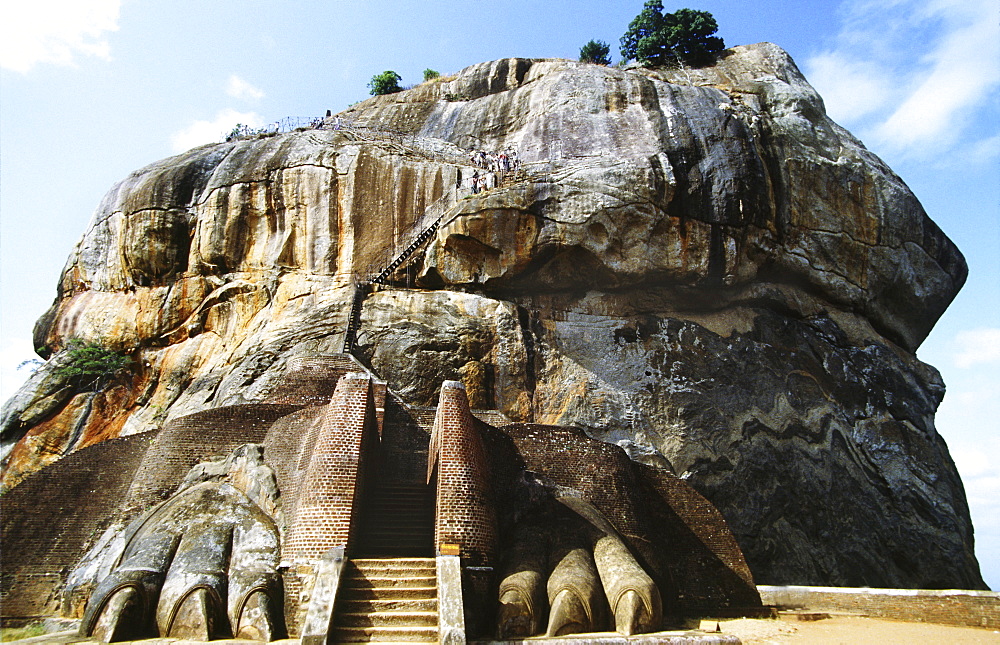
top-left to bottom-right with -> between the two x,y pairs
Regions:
0,0 -> 1000,589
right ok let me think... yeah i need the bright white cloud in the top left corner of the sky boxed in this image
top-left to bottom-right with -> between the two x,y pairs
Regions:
0,0 -> 121,73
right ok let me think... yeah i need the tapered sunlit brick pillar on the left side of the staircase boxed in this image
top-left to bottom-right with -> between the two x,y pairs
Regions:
282,373 -> 379,561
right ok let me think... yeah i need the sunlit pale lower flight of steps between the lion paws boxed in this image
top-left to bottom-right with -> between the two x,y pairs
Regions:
330,558 -> 438,643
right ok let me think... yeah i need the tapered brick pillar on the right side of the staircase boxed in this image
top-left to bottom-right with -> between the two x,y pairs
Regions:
428,381 -> 497,565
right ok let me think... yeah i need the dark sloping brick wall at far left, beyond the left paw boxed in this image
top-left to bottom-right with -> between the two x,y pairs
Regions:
0,432 -> 156,619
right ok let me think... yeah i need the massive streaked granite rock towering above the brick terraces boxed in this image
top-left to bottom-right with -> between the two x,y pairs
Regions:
0,43 -> 983,588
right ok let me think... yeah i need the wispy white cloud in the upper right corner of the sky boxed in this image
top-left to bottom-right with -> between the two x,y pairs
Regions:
805,0 -> 1000,157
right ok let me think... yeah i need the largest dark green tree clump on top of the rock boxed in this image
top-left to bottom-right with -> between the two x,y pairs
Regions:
621,0 -> 726,66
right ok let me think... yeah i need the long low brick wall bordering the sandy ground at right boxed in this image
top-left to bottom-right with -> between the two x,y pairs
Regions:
758,585 -> 1000,629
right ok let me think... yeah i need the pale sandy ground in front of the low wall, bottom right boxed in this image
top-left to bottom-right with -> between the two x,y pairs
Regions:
719,615 -> 1000,645
